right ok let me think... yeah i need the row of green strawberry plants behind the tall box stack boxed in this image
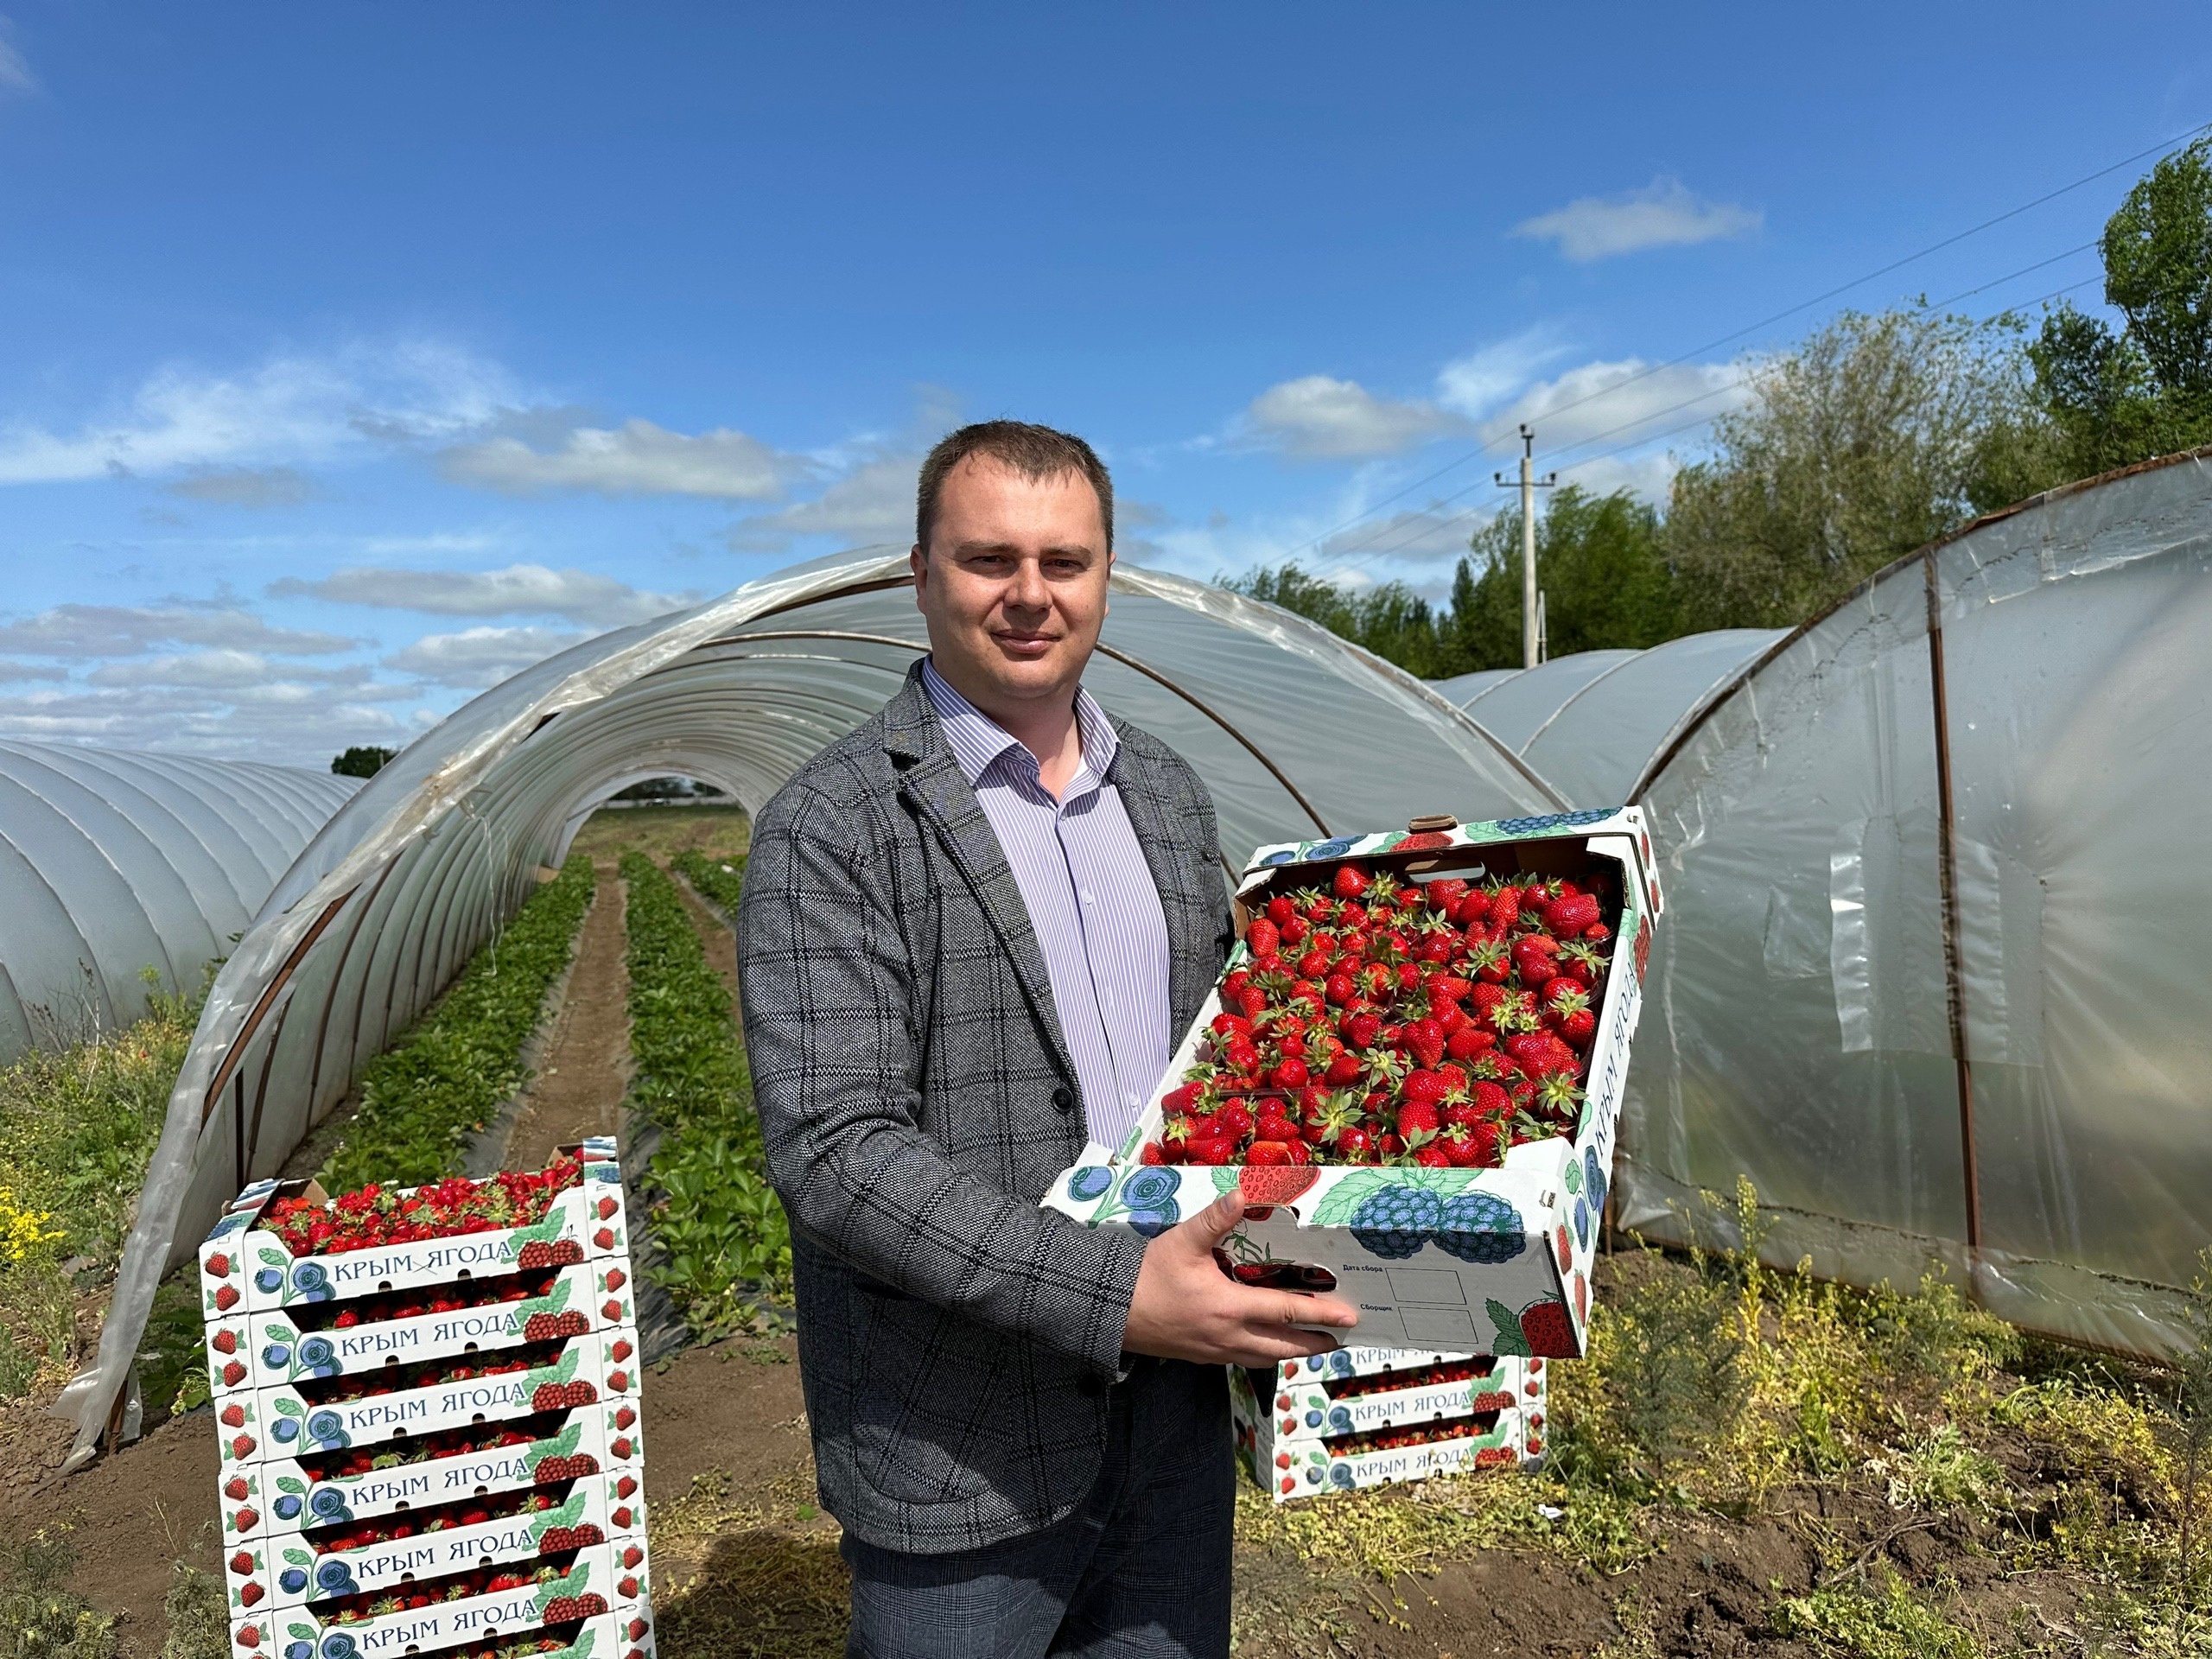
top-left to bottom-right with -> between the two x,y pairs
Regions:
319,858 -> 593,1192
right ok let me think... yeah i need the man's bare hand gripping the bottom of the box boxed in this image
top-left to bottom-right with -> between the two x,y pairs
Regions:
1122,1188 -> 1360,1365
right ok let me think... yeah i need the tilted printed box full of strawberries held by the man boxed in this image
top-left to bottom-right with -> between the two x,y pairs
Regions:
1044,807 -> 1662,1358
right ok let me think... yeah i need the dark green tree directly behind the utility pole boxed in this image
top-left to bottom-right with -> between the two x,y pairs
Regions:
1440,485 -> 1679,672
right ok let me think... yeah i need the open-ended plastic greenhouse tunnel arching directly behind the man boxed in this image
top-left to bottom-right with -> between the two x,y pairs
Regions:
55,549 -> 1560,1466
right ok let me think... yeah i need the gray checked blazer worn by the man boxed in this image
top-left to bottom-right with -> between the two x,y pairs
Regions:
736,664 -> 1232,1555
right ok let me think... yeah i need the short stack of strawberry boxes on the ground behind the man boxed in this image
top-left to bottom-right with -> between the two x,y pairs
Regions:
1230,1356 -> 1544,1504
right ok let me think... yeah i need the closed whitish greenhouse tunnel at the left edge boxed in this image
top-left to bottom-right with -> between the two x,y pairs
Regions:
0,741 -> 360,1064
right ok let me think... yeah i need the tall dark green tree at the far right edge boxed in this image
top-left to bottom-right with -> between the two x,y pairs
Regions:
2029,139 -> 2212,478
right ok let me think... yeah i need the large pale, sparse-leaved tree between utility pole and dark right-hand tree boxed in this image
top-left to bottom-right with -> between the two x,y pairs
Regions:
1663,309 -> 2055,631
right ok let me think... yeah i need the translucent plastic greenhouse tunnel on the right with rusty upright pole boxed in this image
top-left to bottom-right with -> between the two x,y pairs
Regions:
1628,449 -> 2212,1356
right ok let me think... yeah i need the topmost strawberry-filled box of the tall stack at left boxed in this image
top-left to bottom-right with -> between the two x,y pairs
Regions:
199,1137 -> 628,1319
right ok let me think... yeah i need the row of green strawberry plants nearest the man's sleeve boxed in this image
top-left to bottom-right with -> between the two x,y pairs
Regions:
621,852 -> 791,1334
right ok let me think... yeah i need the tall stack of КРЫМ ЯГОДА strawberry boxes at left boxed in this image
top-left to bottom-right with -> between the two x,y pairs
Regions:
201,1137 -> 652,1659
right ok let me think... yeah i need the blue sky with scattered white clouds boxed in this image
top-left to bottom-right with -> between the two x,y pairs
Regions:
0,0 -> 2212,766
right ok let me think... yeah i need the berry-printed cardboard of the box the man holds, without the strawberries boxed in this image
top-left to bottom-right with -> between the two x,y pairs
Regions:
1044,807 -> 1662,1358
